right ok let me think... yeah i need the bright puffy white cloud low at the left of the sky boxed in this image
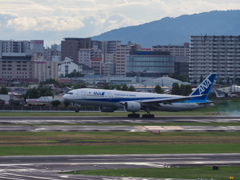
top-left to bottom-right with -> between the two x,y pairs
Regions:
7,16 -> 84,31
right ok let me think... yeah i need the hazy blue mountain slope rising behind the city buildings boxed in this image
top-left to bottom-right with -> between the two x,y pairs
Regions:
91,10 -> 240,48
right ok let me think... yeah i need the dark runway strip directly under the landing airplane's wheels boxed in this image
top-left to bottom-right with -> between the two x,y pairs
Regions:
0,116 -> 240,124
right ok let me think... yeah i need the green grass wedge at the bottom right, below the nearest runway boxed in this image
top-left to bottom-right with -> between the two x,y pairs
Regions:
69,166 -> 240,180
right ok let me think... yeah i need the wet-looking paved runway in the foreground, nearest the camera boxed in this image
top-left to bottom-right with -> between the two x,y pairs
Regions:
0,153 -> 240,180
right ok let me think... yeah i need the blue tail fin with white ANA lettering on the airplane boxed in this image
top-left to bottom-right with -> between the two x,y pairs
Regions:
190,73 -> 217,100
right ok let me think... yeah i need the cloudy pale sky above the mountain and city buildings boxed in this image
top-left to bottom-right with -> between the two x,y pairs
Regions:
0,0 -> 240,46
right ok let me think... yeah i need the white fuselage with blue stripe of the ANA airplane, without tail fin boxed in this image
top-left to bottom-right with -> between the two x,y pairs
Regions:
63,88 -> 212,111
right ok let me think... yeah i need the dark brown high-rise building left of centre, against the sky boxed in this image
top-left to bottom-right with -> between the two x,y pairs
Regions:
61,38 -> 91,62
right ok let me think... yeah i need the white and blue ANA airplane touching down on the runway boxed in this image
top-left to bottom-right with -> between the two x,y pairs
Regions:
63,73 -> 217,118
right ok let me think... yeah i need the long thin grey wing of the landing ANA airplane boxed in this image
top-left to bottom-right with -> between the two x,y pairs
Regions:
142,95 -> 204,104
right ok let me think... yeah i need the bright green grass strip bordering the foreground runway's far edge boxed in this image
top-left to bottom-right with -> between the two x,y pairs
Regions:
0,143 -> 240,156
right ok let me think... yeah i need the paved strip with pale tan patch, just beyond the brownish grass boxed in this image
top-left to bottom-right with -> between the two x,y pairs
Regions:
0,125 -> 240,132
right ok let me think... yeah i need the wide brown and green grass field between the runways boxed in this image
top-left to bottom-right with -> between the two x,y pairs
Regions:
0,132 -> 240,156
